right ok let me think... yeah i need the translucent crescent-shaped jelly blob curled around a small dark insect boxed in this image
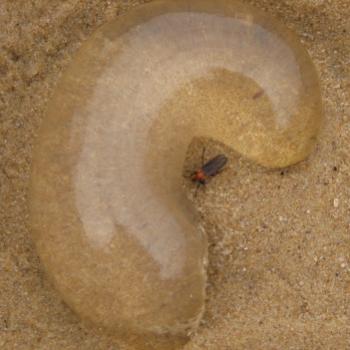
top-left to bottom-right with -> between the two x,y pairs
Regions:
29,0 -> 322,349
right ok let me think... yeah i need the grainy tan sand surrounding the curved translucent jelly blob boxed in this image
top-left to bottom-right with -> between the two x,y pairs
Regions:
0,0 -> 350,350
